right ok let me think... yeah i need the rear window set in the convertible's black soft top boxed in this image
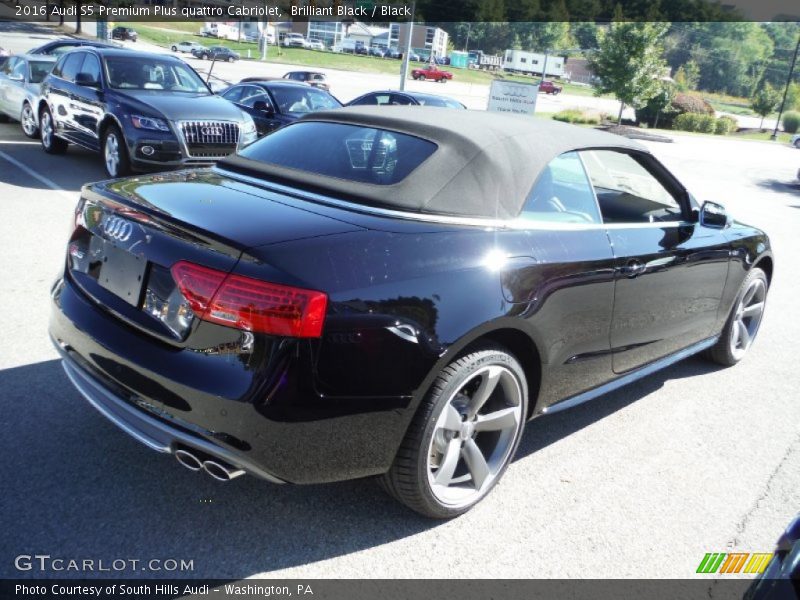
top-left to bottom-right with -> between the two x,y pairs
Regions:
239,121 -> 436,185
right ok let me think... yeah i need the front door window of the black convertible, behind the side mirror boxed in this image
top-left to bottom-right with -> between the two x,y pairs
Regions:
581,150 -> 682,223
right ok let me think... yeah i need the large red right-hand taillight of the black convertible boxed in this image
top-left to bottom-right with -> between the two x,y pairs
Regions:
171,261 -> 328,337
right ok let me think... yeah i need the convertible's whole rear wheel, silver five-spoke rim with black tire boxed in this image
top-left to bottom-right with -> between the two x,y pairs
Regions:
382,347 -> 528,519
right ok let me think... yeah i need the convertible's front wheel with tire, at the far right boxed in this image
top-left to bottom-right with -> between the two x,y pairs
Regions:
707,268 -> 769,367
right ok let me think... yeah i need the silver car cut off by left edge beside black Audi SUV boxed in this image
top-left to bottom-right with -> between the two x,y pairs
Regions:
0,54 -> 56,138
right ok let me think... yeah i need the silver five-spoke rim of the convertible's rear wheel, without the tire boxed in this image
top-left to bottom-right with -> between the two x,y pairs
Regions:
428,365 -> 522,507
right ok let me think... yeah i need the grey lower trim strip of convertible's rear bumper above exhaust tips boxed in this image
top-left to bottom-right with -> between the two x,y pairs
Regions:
53,341 -> 284,483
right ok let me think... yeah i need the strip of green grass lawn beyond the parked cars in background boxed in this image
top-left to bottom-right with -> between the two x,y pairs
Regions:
126,23 -> 611,98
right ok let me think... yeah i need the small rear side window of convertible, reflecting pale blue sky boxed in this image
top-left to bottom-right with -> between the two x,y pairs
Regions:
522,152 -> 601,223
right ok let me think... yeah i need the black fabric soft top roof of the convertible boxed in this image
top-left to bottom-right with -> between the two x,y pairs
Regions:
218,106 -> 647,219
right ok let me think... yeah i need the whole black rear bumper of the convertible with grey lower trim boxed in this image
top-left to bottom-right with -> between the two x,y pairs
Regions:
49,277 -> 412,483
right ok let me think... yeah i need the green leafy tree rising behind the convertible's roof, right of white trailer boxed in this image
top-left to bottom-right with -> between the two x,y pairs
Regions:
589,22 -> 668,123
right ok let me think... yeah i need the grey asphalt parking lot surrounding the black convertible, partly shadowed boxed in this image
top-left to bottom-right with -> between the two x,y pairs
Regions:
0,24 -> 800,584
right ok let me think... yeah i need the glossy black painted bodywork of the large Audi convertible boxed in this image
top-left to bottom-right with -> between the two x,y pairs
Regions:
50,158 -> 772,483
